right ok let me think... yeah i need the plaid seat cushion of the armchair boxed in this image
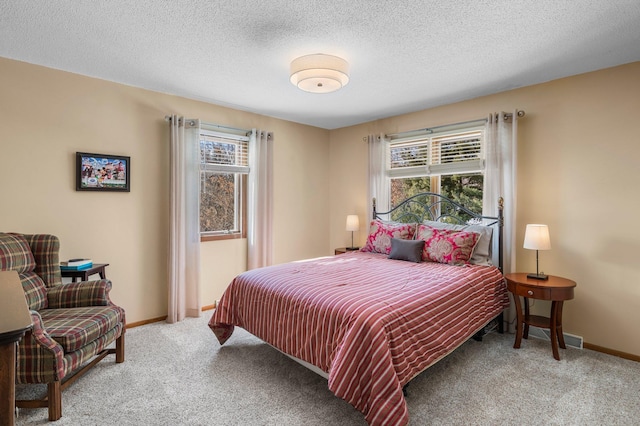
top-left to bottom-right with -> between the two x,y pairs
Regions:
40,306 -> 124,353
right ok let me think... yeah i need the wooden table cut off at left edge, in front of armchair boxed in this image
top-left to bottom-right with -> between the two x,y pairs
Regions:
0,271 -> 32,426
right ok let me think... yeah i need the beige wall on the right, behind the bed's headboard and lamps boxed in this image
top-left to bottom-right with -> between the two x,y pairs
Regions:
330,62 -> 640,356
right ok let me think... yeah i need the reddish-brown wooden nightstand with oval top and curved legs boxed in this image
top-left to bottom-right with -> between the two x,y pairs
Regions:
504,273 -> 576,361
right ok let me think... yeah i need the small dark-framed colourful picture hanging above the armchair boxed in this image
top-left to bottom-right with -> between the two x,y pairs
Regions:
76,152 -> 131,192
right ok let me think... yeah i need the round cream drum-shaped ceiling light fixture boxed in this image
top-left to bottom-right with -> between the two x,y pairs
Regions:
290,53 -> 349,93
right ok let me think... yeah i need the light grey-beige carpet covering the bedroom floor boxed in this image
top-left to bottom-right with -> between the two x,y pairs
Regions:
16,312 -> 640,426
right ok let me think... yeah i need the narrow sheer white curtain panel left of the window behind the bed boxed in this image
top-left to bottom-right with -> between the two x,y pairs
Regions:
367,135 -> 390,221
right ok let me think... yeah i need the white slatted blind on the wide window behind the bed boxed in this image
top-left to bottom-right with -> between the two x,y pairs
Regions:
387,128 -> 484,178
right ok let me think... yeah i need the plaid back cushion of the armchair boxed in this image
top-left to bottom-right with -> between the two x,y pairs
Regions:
0,233 -> 47,310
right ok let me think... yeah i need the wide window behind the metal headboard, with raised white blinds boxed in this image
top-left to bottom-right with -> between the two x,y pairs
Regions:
387,123 -> 484,220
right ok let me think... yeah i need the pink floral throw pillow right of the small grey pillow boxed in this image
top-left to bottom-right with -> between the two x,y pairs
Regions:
416,225 -> 480,265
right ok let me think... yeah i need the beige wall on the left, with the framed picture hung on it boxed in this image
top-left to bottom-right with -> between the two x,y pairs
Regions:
0,58 -> 330,322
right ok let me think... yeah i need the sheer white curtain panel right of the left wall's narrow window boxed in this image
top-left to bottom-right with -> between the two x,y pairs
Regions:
247,129 -> 273,269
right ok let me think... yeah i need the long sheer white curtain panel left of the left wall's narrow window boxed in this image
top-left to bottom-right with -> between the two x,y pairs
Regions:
167,115 -> 202,323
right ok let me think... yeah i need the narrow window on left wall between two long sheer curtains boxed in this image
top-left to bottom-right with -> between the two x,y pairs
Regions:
200,130 -> 249,241
